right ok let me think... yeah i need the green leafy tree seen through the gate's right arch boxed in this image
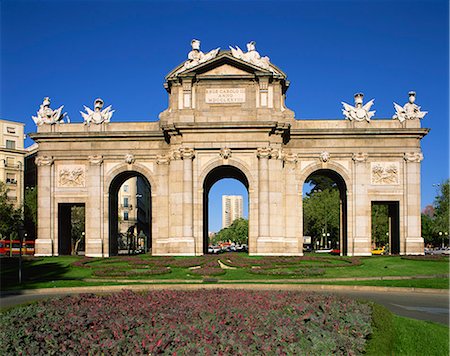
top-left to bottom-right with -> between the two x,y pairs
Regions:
303,188 -> 340,246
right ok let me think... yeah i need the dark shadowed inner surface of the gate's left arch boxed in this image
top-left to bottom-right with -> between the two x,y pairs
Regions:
108,171 -> 152,256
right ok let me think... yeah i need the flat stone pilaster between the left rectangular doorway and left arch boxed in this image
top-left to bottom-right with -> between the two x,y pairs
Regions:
85,155 -> 103,257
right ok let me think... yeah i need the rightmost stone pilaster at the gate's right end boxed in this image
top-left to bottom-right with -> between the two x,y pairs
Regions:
400,152 -> 424,255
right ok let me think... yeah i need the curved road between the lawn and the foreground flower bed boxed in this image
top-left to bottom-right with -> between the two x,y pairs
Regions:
0,284 -> 449,326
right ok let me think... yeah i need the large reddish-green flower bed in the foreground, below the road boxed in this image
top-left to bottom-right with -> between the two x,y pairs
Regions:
0,290 -> 371,355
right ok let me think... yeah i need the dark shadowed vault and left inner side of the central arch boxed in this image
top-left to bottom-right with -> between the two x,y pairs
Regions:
203,164 -> 250,254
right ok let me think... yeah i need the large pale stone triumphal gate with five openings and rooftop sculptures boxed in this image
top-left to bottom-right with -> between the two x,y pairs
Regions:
31,40 -> 428,256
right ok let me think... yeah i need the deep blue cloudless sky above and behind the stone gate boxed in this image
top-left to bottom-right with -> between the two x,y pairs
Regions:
0,0 -> 449,230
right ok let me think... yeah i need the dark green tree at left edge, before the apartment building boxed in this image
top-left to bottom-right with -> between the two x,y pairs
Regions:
0,182 -> 22,239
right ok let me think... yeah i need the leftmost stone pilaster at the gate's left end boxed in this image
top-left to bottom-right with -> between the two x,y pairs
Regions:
35,156 -> 53,256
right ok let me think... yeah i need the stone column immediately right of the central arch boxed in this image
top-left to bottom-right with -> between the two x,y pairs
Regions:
257,147 -> 272,238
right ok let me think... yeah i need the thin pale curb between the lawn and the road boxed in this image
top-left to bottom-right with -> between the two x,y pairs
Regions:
0,283 -> 449,298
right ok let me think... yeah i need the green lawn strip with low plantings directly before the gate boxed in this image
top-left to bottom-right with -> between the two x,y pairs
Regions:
0,254 -> 449,290
